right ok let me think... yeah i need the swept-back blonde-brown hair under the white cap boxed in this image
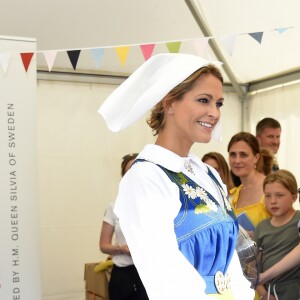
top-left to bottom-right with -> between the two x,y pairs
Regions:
147,64 -> 223,136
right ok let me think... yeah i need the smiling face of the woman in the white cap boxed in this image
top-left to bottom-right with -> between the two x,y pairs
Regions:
166,74 -> 224,148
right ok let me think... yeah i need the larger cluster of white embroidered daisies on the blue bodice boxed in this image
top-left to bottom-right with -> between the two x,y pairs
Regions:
182,184 -> 218,214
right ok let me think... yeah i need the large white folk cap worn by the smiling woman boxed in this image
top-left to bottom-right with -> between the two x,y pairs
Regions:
98,53 -> 221,140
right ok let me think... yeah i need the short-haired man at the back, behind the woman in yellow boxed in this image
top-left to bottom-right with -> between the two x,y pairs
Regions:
256,118 -> 281,172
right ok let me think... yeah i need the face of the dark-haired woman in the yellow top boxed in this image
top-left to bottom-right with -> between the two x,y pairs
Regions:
229,141 -> 259,177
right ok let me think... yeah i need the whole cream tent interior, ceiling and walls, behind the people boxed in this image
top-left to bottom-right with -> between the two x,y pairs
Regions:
0,0 -> 300,300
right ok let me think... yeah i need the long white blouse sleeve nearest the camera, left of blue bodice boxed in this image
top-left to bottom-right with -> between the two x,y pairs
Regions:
114,162 -> 212,300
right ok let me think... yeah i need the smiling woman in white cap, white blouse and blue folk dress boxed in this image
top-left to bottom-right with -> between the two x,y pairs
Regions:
99,54 -> 254,300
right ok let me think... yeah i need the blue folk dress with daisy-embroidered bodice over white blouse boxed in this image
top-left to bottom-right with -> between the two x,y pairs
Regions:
158,165 -> 238,294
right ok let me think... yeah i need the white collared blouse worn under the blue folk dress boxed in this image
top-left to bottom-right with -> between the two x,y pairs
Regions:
114,145 -> 254,300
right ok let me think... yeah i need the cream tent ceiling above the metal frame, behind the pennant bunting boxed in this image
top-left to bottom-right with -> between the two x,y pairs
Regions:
0,0 -> 300,92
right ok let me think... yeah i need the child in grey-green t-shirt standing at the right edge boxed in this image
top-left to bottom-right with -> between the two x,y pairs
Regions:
254,170 -> 300,300
